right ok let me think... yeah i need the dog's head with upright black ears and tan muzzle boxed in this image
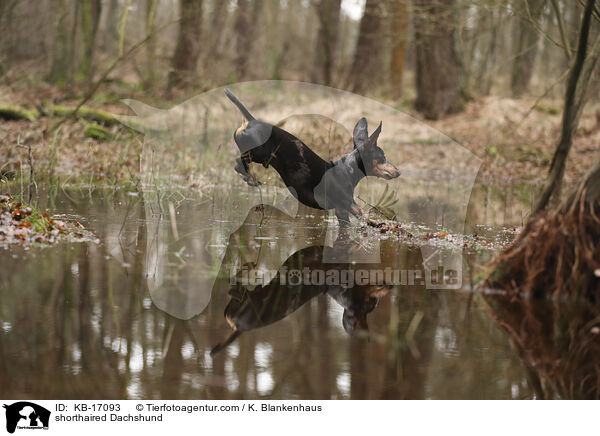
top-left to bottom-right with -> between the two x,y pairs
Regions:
353,117 -> 400,180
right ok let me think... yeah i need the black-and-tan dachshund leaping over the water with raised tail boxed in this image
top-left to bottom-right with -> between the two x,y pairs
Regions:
225,88 -> 400,225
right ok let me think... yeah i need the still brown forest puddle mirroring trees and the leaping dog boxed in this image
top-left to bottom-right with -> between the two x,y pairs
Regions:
0,182 -> 597,399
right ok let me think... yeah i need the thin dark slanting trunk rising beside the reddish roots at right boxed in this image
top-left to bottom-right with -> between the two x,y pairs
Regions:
533,0 -> 600,214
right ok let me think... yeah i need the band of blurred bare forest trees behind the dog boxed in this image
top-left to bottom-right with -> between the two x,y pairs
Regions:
0,0 -> 600,119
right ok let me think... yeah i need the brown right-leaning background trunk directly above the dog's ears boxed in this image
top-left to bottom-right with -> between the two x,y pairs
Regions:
349,0 -> 383,93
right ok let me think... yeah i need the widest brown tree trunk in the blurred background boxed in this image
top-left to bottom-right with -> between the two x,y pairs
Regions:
414,0 -> 464,120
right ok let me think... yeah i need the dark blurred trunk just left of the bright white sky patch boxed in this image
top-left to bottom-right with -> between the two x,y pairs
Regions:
312,0 -> 342,85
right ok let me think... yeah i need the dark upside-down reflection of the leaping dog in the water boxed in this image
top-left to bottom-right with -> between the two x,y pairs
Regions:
211,242 -> 392,356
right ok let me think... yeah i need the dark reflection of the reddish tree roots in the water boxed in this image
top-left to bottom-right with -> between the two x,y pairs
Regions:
487,297 -> 600,399
